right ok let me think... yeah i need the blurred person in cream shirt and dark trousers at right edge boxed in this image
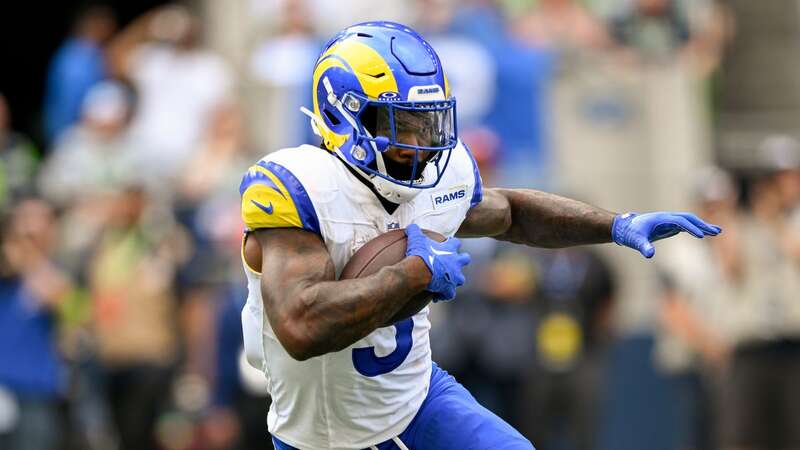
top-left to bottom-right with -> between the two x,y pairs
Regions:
721,138 -> 800,449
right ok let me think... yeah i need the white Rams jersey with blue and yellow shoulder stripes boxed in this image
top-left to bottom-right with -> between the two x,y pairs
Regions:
240,143 -> 482,450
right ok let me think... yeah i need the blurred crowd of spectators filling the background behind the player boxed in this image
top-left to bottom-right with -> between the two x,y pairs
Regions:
0,0 -> 800,450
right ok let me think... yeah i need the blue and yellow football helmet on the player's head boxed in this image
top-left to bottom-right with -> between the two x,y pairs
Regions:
303,22 -> 458,203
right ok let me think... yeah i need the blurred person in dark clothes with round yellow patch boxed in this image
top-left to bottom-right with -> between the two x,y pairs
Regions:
527,244 -> 616,450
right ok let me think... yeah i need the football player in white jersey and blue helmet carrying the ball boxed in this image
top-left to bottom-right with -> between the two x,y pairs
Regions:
240,22 -> 720,450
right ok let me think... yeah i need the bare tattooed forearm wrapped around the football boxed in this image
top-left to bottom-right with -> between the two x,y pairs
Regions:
268,257 -> 430,359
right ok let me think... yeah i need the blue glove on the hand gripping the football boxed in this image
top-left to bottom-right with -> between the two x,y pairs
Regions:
406,223 -> 470,302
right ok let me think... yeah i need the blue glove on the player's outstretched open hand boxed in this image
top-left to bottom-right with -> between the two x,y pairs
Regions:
611,212 -> 722,258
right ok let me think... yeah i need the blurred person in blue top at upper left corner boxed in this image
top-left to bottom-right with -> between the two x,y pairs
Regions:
44,6 -> 117,143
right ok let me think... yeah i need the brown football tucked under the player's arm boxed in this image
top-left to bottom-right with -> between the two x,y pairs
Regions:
339,230 -> 447,326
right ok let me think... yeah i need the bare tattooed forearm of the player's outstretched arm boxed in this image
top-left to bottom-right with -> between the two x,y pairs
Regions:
496,189 -> 615,248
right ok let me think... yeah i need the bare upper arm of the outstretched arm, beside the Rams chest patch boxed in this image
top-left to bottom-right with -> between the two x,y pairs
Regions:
456,189 -> 511,237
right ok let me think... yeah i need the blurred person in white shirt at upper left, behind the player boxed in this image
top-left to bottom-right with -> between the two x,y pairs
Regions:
109,5 -> 234,188
